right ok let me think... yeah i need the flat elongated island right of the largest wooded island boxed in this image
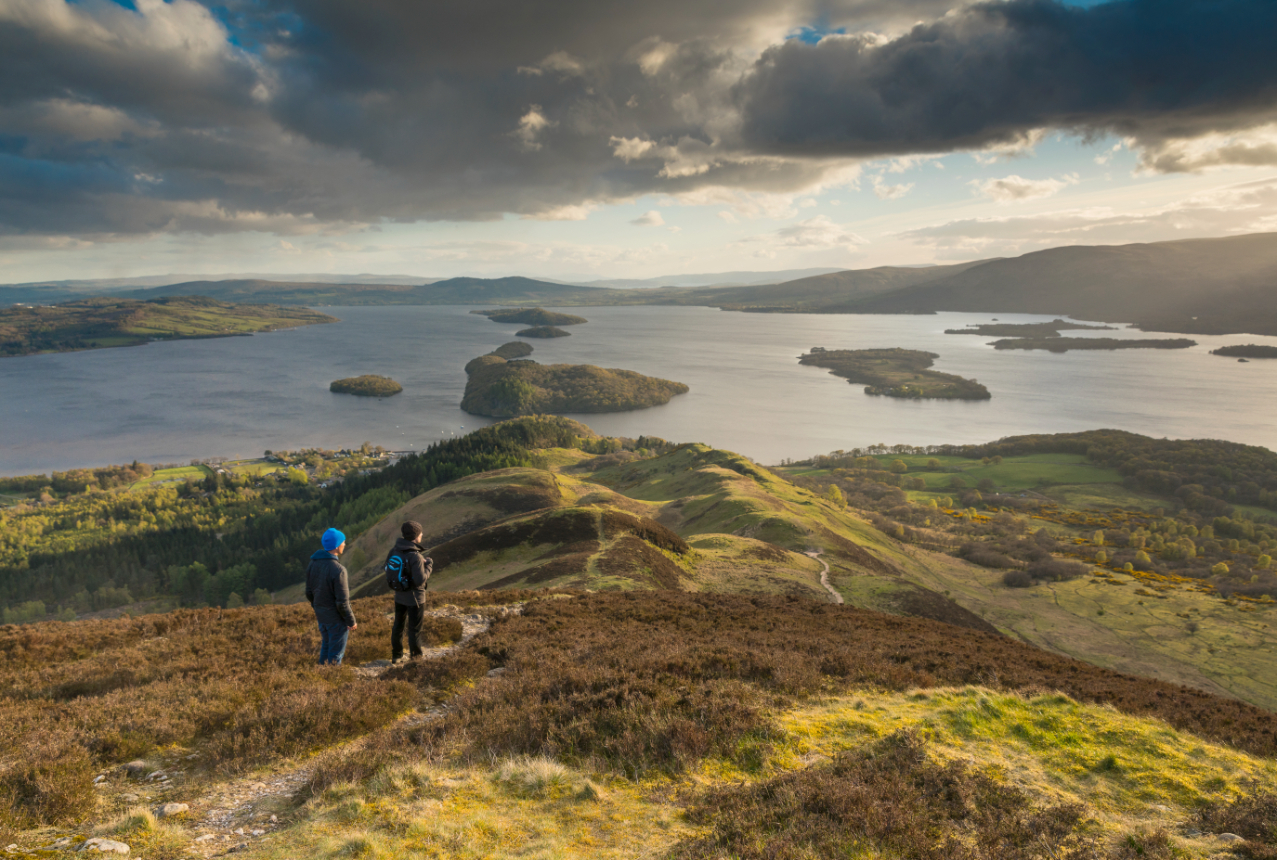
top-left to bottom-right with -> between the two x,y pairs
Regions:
798,346 -> 992,400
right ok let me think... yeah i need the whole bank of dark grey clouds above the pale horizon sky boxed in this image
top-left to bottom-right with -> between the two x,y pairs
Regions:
0,0 -> 1274,237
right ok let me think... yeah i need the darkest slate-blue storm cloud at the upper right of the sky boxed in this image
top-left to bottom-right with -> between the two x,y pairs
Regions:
736,0 -> 1277,156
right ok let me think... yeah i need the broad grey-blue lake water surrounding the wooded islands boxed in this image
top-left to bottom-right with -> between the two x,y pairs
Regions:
0,307 -> 1277,475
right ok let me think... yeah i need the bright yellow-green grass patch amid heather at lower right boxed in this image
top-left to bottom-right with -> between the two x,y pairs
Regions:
775,687 -> 1277,848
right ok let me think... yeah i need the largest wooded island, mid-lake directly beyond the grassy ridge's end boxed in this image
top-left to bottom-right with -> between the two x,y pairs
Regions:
461,348 -> 688,418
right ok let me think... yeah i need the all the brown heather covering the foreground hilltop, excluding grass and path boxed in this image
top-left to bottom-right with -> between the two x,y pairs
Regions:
0,590 -> 1277,860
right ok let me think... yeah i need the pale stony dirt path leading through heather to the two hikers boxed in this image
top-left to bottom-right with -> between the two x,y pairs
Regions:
114,604 -> 510,857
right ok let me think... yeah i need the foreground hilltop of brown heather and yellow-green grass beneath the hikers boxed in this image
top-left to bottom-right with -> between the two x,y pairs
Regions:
0,592 -> 1277,860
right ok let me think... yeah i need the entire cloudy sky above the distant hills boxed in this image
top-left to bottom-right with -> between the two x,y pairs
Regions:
0,0 -> 1277,282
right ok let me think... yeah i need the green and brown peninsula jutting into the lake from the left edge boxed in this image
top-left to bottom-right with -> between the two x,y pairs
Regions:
0,295 -> 340,355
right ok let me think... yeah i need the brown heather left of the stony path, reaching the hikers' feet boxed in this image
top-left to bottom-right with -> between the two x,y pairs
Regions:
0,598 -> 469,824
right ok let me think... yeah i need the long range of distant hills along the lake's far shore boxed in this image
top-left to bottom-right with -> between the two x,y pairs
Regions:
7,233 -> 1277,335
